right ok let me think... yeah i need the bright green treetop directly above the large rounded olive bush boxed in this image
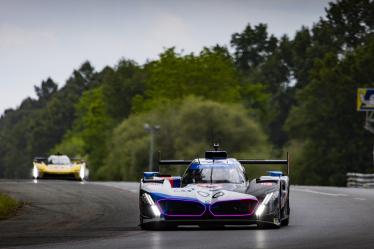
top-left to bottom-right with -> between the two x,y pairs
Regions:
135,48 -> 240,110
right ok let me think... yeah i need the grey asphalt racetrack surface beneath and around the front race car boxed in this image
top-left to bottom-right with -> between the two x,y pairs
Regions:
0,181 -> 374,249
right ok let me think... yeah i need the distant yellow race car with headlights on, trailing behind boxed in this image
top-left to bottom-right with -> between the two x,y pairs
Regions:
32,154 -> 88,181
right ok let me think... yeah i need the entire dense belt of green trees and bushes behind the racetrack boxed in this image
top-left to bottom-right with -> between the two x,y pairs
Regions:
0,0 -> 374,185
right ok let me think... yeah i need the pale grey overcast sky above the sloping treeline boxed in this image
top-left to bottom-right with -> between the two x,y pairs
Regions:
0,0 -> 329,114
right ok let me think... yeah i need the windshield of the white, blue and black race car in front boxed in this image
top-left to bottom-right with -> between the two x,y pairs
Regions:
183,165 -> 245,185
